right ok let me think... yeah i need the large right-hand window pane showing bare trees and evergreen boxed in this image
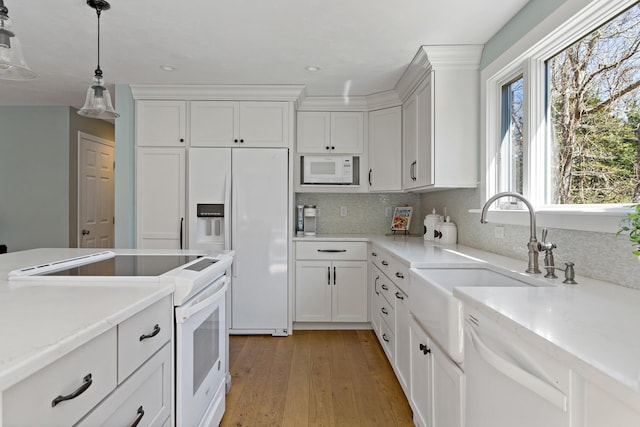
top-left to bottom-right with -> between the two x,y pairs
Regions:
546,5 -> 640,204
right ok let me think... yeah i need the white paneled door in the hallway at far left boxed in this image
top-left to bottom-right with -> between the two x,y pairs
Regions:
78,132 -> 114,248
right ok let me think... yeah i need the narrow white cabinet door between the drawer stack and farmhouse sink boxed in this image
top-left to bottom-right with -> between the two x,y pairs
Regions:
394,289 -> 411,397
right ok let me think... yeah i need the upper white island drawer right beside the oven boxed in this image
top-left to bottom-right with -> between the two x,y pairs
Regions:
118,296 -> 173,384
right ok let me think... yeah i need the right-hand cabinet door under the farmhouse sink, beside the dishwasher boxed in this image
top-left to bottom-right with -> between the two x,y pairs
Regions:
431,345 -> 462,427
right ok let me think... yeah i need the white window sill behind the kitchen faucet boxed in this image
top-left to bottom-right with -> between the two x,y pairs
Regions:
469,205 -> 631,233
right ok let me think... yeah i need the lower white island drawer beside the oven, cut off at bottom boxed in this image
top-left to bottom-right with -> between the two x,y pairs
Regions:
78,344 -> 171,427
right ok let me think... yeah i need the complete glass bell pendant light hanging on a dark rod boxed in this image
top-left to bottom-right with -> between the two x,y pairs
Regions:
78,0 -> 120,119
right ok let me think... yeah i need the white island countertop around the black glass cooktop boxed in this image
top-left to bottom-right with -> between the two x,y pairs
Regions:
0,249 -> 202,391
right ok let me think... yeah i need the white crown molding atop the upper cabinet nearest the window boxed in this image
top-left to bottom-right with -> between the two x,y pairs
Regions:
394,45 -> 484,102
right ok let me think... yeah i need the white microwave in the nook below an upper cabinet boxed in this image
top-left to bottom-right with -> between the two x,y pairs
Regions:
302,155 -> 354,184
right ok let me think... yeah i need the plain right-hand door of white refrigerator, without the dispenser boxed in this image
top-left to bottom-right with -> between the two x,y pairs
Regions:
231,148 -> 289,332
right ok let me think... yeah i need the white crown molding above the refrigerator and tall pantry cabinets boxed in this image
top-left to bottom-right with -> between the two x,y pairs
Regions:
130,84 -> 306,103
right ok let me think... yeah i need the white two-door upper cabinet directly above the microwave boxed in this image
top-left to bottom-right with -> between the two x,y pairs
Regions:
296,111 -> 364,154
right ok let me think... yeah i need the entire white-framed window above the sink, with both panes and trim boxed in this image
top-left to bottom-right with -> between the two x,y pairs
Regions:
481,0 -> 640,232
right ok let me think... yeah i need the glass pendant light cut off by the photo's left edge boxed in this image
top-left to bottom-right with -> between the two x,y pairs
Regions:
0,0 -> 37,80
